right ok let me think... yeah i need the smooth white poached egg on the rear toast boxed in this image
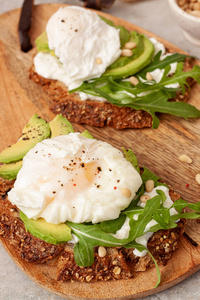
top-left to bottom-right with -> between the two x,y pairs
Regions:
34,6 -> 121,90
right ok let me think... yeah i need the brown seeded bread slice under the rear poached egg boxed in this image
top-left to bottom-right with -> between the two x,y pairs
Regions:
29,56 -> 194,129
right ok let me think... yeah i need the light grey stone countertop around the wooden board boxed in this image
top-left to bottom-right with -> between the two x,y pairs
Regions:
0,0 -> 200,300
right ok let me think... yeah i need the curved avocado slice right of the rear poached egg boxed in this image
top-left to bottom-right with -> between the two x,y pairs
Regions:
102,36 -> 154,79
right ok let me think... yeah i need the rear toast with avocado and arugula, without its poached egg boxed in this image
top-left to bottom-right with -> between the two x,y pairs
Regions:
29,12 -> 200,129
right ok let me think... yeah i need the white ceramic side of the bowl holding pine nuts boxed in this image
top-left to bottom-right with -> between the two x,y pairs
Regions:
168,0 -> 200,47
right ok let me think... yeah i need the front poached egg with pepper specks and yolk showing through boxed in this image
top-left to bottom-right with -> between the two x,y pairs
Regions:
8,133 -> 142,224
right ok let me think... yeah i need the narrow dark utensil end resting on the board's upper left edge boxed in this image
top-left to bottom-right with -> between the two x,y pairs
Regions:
18,0 -> 33,52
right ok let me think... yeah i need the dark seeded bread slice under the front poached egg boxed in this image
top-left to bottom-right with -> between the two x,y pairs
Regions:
0,179 -> 185,282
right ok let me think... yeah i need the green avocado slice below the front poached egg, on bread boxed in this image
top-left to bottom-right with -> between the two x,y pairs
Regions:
20,211 -> 72,245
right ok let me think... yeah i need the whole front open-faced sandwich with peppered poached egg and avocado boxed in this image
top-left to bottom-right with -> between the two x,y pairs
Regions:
0,115 -> 200,284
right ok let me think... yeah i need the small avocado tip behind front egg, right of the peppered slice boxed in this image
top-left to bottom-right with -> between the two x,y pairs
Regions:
49,114 -> 74,138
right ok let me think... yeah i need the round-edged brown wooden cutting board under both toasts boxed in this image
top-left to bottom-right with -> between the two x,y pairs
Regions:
0,4 -> 200,299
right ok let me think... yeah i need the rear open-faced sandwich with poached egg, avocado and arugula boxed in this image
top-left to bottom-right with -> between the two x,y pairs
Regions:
30,6 -> 200,129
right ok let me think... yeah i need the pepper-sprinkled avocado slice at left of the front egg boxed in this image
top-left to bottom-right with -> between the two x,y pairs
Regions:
0,114 -> 50,164
